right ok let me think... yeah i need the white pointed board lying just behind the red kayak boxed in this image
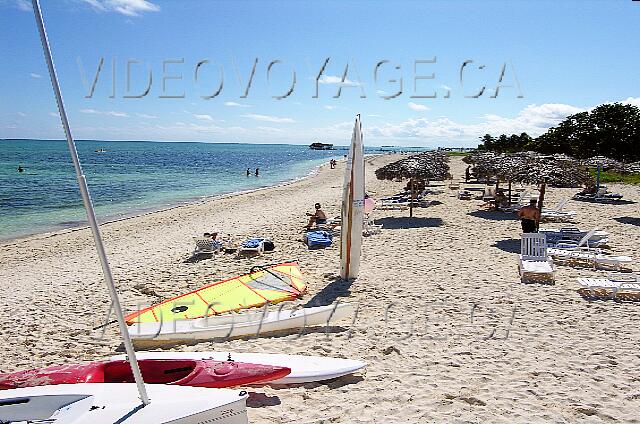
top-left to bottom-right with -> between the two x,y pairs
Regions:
112,351 -> 367,384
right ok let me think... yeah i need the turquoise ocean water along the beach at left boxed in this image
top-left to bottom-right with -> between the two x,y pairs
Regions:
0,140 -> 346,240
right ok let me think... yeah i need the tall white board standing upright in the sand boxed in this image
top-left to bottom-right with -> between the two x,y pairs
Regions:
340,115 -> 364,280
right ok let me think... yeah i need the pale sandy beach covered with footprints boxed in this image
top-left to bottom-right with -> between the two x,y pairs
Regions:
0,155 -> 640,423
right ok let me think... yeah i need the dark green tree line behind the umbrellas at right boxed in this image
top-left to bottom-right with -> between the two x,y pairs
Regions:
478,103 -> 640,162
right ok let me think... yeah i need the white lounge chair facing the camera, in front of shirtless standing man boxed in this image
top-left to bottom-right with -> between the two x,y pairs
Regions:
518,233 -> 556,283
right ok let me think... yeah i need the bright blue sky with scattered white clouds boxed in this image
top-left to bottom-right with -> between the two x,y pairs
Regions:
0,0 -> 640,146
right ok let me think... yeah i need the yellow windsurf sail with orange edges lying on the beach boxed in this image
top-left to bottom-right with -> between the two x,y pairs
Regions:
125,262 -> 306,325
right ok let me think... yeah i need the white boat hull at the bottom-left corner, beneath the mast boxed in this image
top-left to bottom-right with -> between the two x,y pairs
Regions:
0,383 -> 248,424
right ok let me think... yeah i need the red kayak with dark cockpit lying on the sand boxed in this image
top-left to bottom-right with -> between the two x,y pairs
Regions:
0,359 -> 291,389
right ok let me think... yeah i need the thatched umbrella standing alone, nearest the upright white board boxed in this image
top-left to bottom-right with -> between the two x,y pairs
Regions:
376,152 -> 451,216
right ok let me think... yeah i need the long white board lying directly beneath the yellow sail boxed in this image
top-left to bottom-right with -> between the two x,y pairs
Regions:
129,303 -> 355,344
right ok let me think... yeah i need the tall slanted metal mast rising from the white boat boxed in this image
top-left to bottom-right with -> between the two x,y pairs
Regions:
31,0 -> 150,405
